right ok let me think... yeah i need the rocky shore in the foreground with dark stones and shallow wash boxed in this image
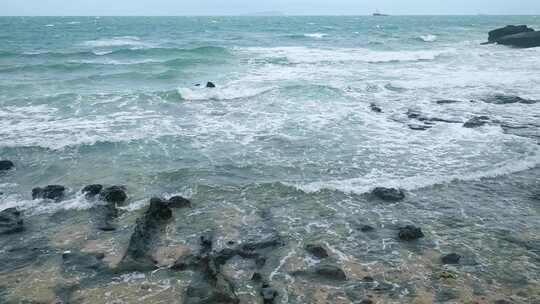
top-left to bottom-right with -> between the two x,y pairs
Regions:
0,160 -> 540,303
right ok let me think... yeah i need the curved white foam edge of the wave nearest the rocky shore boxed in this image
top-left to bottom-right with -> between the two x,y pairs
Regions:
292,155 -> 540,194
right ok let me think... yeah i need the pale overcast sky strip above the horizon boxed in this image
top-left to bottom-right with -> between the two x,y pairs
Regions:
0,0 -> 540,16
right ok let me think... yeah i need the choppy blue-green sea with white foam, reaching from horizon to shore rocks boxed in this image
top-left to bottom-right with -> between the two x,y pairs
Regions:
0,16 -> 540,303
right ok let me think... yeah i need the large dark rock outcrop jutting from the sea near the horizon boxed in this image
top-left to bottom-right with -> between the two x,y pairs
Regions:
488,25 -> 540,48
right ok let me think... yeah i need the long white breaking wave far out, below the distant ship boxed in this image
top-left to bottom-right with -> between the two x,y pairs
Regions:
237,47 -> 455,64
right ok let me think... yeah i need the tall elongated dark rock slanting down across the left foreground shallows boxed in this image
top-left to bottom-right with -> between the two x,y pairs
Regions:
119,198 -> 172,271
